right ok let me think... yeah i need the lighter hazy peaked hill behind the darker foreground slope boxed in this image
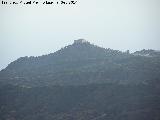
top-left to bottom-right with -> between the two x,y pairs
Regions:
0,39 -> 160,86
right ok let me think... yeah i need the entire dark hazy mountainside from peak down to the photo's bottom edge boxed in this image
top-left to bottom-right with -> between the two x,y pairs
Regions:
0,39 -> 160,120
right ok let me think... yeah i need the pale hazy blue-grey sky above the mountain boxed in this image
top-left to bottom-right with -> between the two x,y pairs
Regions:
0,0 -> 160,69
